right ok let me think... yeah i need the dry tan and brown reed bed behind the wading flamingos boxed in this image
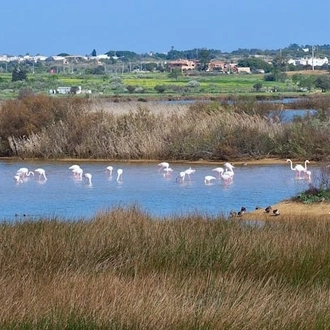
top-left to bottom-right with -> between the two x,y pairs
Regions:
0,96 -> 330,161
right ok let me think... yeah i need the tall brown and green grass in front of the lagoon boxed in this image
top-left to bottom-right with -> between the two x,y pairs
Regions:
0,206 -> 330,330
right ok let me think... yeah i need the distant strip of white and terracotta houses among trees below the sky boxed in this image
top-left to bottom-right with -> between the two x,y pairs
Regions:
0,44 -> 330,74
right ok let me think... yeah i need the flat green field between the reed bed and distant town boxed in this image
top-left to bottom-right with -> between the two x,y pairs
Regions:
0,72 -> 310,99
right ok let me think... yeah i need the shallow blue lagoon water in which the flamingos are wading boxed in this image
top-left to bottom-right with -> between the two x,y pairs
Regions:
0,161 -> 317,221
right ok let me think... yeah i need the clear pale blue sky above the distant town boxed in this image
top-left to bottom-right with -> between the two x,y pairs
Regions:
0,0 -> 330,56
